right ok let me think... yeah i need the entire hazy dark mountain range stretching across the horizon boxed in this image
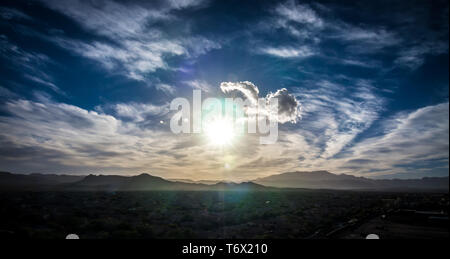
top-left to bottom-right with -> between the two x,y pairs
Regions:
0,171 -> 449,191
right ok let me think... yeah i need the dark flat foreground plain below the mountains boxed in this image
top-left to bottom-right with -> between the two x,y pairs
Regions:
0,190 -> 449,239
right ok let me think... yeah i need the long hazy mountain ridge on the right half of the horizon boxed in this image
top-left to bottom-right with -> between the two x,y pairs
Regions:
253,171 -> 449,191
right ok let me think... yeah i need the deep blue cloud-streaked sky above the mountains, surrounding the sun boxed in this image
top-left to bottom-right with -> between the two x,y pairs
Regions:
0,0 -> 449,181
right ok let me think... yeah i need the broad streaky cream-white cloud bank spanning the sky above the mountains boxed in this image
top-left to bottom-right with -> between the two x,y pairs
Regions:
0,93 -> 449,180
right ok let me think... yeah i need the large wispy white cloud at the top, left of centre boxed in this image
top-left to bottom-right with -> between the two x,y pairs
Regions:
43,0 -> 221,81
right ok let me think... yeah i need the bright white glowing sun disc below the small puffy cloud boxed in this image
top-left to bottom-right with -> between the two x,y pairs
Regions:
204,118 -> 235,146
